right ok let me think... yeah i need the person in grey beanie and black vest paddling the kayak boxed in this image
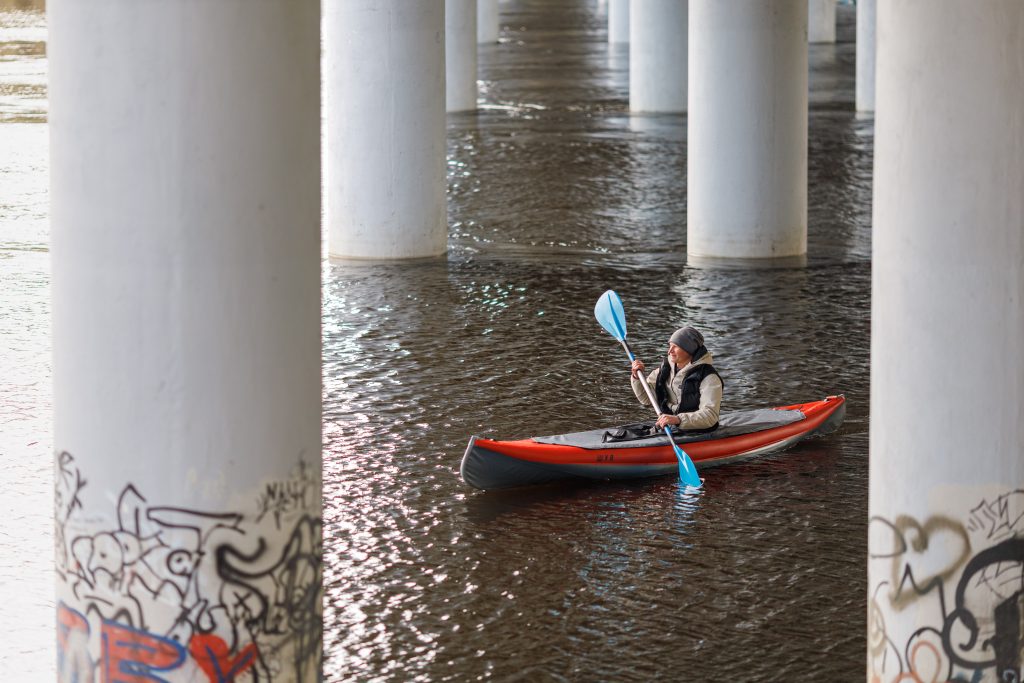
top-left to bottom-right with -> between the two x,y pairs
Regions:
630,327 -> 725,431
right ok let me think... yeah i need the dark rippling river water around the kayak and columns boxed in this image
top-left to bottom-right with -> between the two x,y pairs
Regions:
0,0 -> 872,682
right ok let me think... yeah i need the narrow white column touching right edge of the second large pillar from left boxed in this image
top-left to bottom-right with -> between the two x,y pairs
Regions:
444,0 -> 476,112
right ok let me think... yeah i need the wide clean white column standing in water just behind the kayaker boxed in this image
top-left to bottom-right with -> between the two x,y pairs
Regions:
687,0 -> 807,258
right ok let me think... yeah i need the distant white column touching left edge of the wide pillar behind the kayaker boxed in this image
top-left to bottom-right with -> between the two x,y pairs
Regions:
630,0 -> 687,112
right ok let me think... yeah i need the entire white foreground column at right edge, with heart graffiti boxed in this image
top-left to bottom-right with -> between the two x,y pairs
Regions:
868,0 -> 1024,681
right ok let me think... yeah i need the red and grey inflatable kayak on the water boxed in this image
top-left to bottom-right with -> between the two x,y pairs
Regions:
461,395 -> 846,488
